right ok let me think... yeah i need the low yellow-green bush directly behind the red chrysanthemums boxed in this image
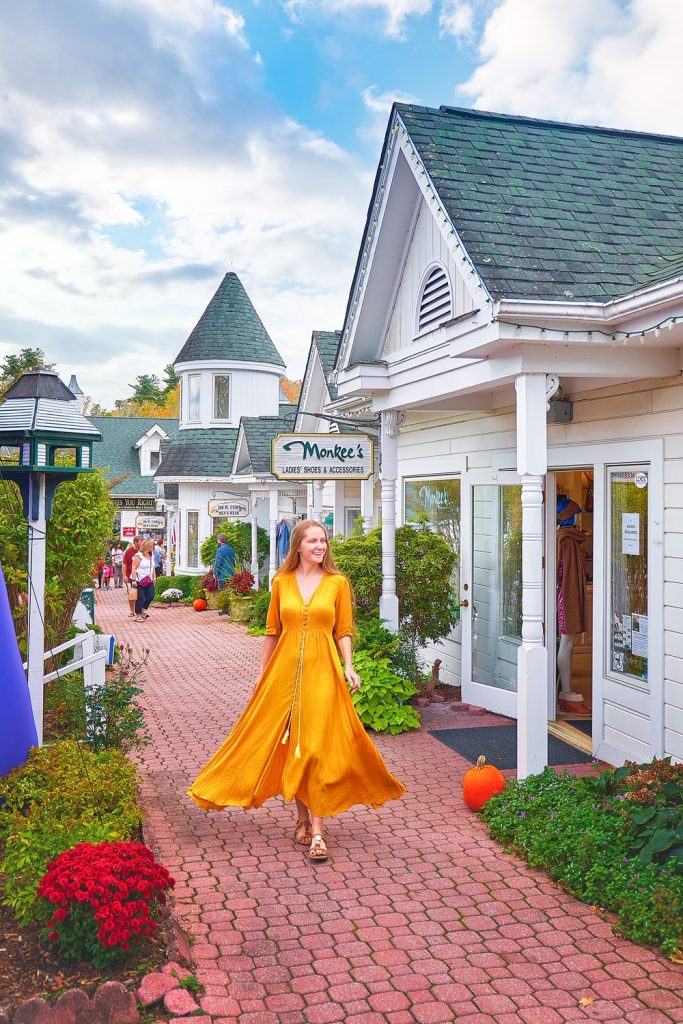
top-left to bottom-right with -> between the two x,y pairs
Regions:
0,740 -> 141,921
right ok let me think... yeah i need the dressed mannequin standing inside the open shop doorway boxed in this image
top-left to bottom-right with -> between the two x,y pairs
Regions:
557,495 -> 592,716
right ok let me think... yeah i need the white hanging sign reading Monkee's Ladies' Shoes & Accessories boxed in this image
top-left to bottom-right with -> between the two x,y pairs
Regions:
270,434 -> 375,480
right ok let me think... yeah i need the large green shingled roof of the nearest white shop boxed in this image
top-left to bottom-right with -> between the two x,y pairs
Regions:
395,103 -> 683,302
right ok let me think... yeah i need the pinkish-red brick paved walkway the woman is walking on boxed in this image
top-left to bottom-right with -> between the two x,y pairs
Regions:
97,591 -> 683,1024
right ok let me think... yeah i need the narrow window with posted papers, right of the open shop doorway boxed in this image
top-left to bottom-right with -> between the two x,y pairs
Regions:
607,468 -> 648,683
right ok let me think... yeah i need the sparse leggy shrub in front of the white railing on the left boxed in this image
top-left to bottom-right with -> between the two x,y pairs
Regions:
45,644 -> 150,753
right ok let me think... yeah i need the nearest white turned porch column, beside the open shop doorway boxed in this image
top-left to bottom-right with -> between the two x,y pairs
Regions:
515,374 -> 548,778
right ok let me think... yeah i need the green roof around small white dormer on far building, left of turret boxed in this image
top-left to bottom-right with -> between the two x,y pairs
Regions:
87,416 -> 178,496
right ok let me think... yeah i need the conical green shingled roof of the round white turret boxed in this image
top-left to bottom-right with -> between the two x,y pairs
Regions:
174,271 -> 285,367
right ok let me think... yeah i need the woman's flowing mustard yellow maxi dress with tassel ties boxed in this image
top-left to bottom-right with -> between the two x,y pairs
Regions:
188,572 -> 405,817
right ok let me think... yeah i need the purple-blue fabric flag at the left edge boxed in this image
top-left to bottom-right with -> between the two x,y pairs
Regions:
0,565 -> 38,775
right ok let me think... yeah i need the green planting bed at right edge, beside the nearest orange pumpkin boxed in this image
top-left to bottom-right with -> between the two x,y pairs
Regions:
482,760 -> 683,955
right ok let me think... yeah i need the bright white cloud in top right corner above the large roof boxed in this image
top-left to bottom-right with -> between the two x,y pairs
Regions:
456,0 -> 683,135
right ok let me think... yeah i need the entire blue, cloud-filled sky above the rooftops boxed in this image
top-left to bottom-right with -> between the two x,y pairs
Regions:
0,0 -> 683,406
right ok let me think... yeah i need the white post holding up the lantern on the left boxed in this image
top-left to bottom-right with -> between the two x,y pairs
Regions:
27,473 -> 47,746
